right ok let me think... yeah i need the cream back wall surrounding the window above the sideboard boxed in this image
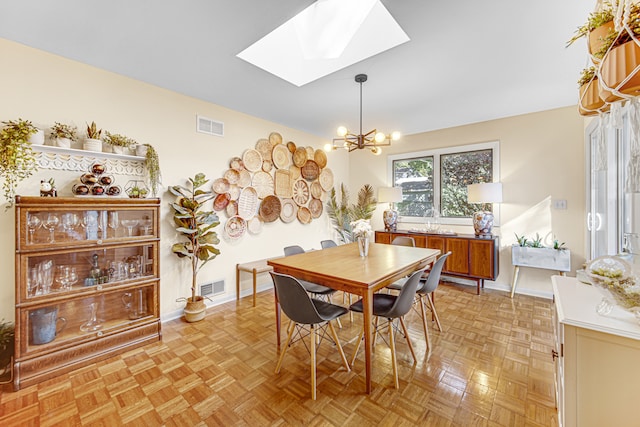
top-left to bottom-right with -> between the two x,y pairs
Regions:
349,106 -> 585,296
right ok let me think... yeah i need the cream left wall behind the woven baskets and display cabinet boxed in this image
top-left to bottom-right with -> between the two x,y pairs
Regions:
0,39 -> 348,319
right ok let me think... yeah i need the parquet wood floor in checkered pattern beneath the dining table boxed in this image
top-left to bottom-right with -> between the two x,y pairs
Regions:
0,284 -> 558,427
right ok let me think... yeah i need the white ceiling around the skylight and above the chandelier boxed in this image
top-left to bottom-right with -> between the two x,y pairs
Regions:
0,0 -> 595,138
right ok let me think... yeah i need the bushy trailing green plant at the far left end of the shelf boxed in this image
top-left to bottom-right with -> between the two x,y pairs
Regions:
0,119 -> 38,209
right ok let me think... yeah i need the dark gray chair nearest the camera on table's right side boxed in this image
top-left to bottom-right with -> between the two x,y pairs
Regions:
349,270 -> 423,388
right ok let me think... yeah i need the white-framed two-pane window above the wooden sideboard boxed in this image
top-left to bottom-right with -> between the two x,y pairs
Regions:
389,141 -> 500,224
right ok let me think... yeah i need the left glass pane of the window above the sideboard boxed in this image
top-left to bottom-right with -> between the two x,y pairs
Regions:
393,156 -> 433,217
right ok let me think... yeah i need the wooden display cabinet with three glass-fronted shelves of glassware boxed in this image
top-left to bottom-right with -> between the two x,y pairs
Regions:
14,196 -> 161,390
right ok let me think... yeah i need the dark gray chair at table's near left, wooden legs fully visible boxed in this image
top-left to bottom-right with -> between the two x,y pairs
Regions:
271,272 -> 351,400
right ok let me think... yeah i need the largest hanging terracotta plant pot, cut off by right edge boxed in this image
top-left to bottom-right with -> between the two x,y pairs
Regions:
600,40 -> 640,102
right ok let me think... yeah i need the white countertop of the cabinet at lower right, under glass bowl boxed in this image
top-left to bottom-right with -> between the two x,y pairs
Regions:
551,276 -> 640,340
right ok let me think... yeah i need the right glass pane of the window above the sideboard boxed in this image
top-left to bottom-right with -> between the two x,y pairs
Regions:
440,150 -> 493,217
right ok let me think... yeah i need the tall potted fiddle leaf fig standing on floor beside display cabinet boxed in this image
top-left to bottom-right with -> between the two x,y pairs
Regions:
169,173 -> 220,322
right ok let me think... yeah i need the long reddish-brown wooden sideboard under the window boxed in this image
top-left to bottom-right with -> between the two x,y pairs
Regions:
376,230 -> 499,295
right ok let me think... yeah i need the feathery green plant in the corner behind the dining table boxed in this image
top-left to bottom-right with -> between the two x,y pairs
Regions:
326,184 -> 377,243
